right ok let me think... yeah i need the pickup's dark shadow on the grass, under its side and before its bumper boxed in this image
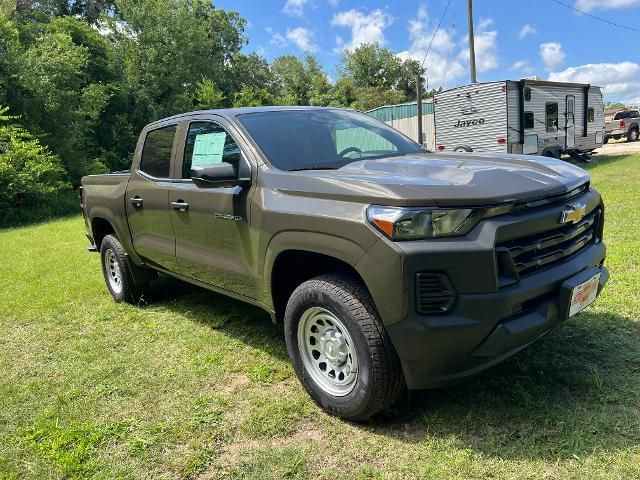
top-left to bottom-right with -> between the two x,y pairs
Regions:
142,277 -> 640,460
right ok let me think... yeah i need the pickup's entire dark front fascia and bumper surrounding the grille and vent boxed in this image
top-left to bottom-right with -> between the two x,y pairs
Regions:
374,190 -> 609,389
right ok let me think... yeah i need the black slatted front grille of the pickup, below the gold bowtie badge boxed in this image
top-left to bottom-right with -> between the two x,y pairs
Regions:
496,209 -> 602,278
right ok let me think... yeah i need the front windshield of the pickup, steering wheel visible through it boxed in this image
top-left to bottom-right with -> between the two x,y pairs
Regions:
237,109 -> 422,171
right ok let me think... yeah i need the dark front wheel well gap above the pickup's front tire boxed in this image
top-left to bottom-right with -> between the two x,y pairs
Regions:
271,250 -> 366,320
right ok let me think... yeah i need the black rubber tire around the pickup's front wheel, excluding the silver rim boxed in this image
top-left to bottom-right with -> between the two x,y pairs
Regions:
284,275 -> 405,420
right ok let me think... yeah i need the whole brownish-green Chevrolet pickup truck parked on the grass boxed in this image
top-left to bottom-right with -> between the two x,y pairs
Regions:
81,107 -> 608,420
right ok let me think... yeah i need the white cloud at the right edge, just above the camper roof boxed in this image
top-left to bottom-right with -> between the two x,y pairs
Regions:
549,62 -> 640,105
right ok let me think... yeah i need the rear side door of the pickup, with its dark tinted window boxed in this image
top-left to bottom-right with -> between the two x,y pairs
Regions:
125,124 -> 177,270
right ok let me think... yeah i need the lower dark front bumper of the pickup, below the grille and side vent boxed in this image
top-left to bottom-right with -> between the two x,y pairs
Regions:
387,243 -> 609,389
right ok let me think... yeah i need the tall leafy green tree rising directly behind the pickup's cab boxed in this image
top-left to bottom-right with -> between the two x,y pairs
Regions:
109,0 -> 246,124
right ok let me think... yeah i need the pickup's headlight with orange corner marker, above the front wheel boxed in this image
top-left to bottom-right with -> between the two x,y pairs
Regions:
367,205 -> 485,240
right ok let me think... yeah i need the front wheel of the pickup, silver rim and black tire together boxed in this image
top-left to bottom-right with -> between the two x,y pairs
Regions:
285,275 -> 405,420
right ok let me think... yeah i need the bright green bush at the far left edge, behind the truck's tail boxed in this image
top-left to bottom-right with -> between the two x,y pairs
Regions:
0,106 -> 71,225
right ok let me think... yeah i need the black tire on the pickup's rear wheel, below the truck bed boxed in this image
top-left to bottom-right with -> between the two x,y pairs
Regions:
100,235 -> 149,305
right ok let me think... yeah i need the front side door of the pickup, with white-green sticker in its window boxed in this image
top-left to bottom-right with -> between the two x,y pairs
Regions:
169,119 -> 256,298
